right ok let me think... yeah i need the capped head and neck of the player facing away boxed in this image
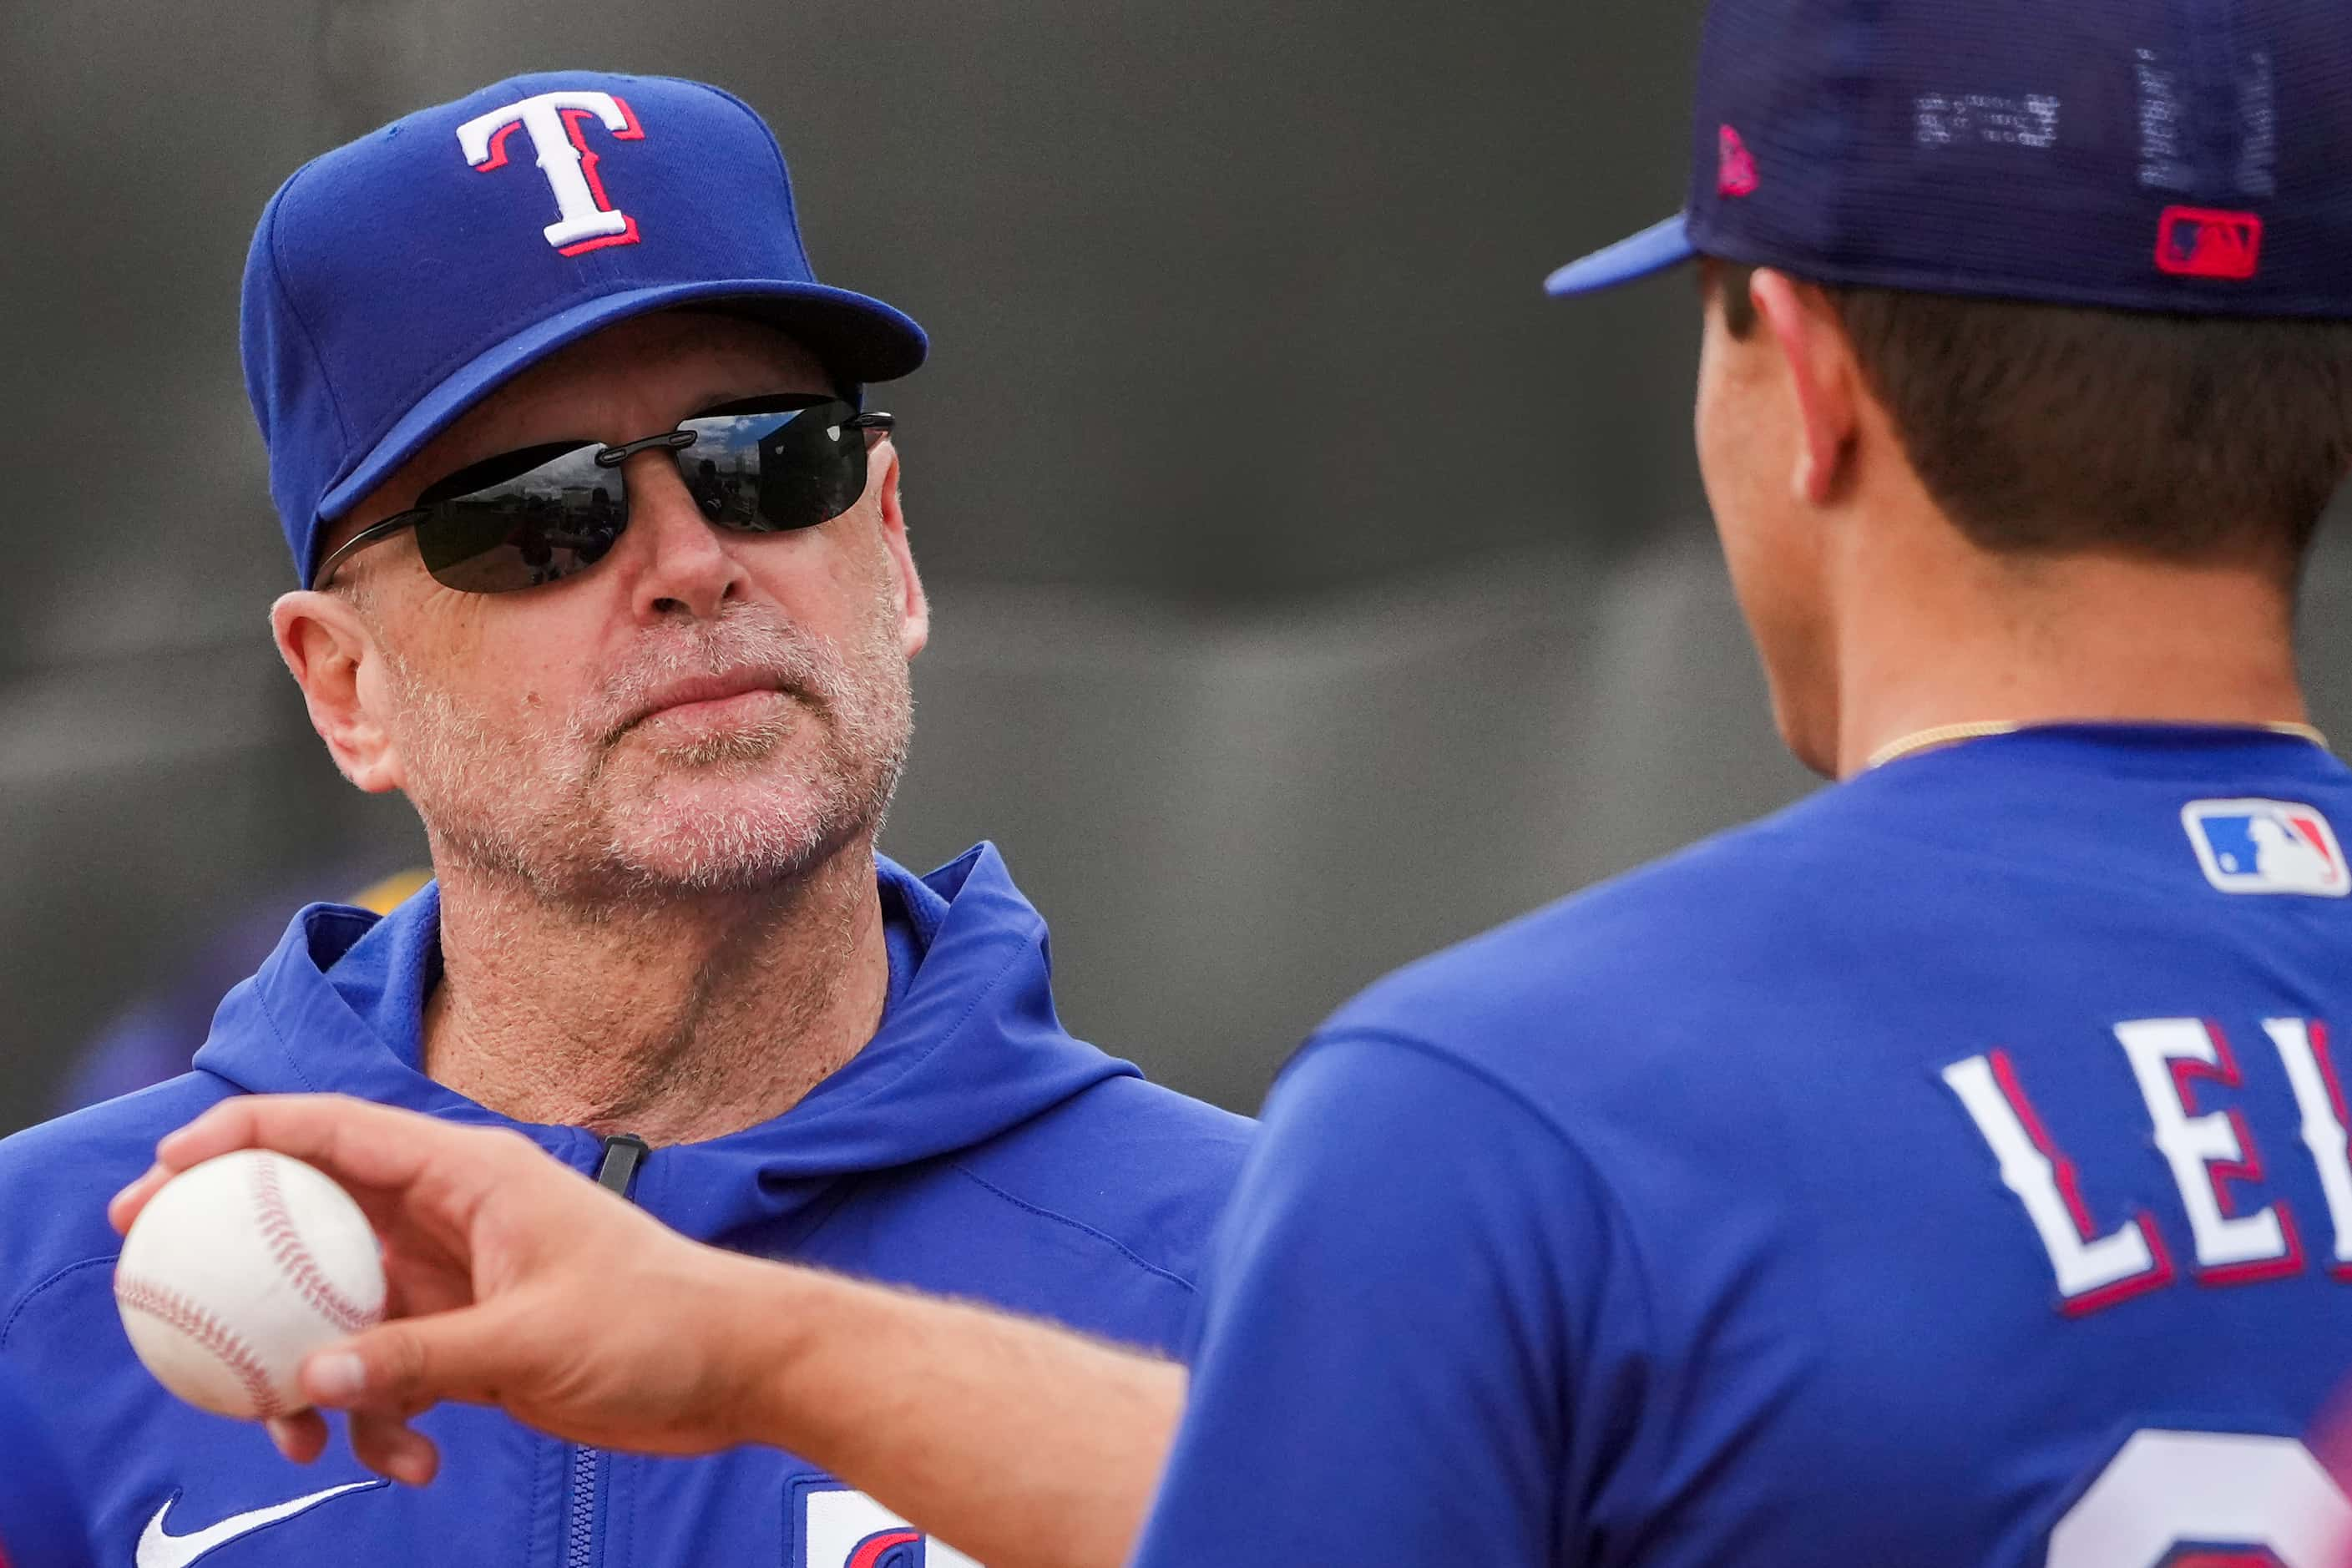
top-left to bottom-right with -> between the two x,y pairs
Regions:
1548,0 -> 2352,773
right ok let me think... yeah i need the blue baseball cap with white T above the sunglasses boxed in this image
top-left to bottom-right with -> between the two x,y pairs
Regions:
242,70 -> 927,585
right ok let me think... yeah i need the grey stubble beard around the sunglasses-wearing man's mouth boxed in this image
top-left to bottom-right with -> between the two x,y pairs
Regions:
388,599 -> 913,910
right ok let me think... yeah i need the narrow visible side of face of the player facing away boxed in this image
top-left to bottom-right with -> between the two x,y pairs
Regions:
1698,261 -> 1837,773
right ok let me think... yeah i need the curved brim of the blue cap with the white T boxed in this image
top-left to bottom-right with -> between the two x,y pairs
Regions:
313,277 -> 929,524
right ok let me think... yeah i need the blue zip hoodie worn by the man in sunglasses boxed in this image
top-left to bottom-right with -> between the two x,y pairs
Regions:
0,844 -> 1249,1568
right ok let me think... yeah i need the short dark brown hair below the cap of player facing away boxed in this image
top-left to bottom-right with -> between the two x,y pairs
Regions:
1715,263 -> 2352,576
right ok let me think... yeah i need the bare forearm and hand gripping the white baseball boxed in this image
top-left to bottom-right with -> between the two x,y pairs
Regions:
109,1095 -> 1186,1568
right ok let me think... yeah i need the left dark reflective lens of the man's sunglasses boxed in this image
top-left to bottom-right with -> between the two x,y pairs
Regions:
417,442 -> 628,593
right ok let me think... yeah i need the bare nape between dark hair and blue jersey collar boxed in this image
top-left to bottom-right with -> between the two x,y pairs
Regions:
1837,534 -> 2305,778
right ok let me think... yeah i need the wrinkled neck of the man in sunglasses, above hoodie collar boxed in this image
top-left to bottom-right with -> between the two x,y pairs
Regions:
423,842 -> 889,1145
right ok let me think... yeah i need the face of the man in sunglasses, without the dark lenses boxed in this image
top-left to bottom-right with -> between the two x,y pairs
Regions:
308,312 -> 929,900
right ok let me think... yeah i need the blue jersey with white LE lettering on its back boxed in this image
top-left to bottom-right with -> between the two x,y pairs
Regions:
1138,726 -> 2352,1568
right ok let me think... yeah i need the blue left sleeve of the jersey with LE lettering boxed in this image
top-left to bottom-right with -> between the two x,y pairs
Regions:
1136,1037 -> 1611,1568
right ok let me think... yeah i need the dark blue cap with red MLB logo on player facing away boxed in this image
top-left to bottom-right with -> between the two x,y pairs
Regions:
1545,0 -> 2352,317
